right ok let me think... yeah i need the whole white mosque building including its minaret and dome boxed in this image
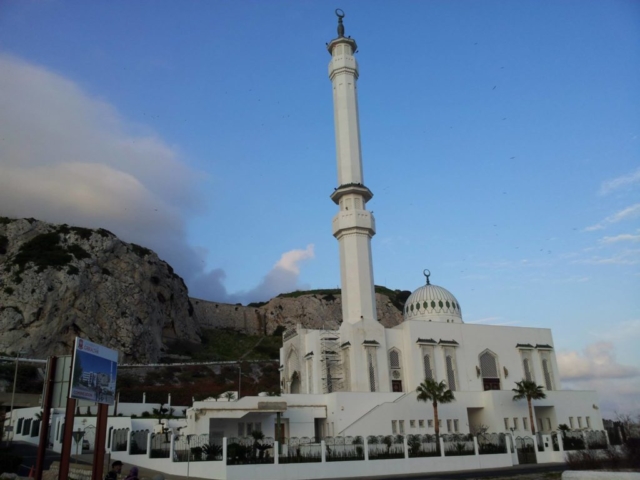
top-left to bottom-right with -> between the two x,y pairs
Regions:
188,11 -> 603,446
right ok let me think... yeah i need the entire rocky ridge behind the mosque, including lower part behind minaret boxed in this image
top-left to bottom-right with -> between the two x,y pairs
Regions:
0,217 -> 410,363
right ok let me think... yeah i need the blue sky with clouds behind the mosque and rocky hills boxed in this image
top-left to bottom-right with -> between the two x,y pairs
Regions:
0,0 -> 640,411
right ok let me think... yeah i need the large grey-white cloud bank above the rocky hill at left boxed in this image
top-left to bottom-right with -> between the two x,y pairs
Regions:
0,54 -> 313,301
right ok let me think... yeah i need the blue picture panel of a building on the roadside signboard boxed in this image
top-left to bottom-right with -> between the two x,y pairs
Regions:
69,337 -> 118,405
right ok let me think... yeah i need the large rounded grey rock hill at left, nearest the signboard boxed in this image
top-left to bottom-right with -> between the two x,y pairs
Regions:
0,217 -> 200,362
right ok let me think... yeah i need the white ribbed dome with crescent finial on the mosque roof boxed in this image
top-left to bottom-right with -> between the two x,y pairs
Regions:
403,270 -> 464,323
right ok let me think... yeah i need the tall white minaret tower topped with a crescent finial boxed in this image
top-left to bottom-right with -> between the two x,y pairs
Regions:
327,9 -> 378,324
